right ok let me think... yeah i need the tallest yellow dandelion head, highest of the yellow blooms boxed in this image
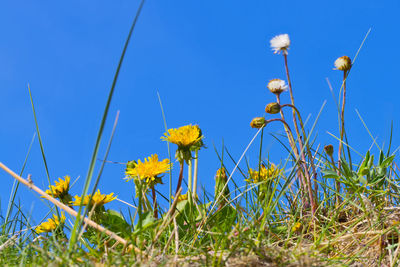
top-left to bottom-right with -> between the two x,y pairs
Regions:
161,125 -> 203,148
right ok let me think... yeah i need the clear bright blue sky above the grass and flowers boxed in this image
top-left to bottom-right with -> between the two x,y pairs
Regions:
0,0 -> 400,222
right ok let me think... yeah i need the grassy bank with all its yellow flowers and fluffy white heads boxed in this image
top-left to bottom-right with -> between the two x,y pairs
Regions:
0,9 -> 400,266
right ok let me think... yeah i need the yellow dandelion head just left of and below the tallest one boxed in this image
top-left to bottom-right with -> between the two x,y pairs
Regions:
125,154 -> 170,185
